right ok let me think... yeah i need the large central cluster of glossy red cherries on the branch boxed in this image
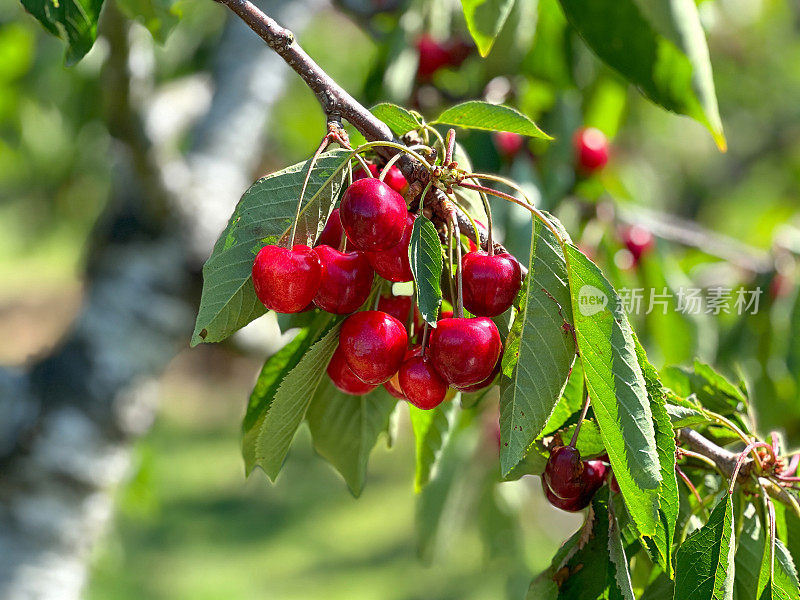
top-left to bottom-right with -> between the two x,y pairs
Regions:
253,162 -> 522,409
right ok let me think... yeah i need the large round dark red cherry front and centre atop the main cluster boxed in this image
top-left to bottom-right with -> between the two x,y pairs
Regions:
339,177 -> 408,252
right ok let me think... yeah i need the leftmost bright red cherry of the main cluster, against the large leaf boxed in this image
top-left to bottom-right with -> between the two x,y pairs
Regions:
253,245 -> 322,313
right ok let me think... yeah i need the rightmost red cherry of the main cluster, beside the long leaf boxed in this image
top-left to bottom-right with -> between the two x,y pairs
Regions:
461,250 -> 522,317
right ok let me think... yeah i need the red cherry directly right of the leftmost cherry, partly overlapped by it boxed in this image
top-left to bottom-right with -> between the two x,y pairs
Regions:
314,246 -> 373,315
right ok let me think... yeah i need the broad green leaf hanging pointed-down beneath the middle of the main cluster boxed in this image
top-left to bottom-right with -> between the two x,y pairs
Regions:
306,378 -> 397,496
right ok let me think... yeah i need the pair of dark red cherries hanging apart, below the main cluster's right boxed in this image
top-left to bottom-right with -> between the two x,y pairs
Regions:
542,446 -> 608,512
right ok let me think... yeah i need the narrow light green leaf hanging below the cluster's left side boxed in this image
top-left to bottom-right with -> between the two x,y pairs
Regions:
252,324 -> 339,481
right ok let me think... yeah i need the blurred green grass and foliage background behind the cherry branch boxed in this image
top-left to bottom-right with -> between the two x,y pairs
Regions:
0,0 -> 800,600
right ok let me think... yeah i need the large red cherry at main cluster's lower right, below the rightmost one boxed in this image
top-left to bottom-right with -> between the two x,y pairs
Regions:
430,317 -> 503,387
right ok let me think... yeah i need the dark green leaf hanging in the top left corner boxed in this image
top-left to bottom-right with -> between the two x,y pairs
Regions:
22,0 -> 103,65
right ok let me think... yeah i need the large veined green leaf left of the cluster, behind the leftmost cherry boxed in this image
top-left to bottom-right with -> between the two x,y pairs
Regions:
191,149 -> 350,346
